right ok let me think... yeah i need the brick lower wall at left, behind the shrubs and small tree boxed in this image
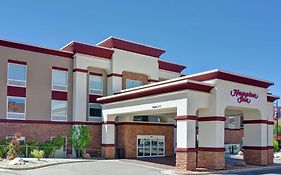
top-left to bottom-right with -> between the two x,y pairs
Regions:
0,122 -> 102,153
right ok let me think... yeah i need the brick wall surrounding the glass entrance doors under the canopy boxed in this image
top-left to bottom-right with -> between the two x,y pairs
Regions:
116,122 -> 174,158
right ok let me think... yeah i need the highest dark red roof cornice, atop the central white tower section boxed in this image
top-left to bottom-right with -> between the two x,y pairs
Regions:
97,37 -> 165,58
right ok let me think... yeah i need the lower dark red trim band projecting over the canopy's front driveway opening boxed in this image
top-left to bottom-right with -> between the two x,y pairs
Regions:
98,81 -> 213,103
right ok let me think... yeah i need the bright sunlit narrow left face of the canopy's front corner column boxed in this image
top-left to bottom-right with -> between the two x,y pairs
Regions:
176,115 -> 197,170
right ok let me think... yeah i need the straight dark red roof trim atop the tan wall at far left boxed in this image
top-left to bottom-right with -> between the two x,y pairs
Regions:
0,40 -> 73,59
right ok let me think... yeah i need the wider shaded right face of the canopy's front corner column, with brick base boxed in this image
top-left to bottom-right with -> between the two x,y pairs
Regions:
197,116 -> 225,169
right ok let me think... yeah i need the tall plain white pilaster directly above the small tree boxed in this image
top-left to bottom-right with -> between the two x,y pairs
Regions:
72,68 -> 88,121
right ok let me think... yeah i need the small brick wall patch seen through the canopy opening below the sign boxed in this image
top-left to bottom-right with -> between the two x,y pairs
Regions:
224,129 -> 244,144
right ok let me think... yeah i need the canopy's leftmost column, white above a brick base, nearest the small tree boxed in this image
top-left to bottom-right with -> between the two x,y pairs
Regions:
101,121 -> 115,159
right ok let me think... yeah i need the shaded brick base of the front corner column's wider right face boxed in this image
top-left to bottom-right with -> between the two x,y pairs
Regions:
198,151 -> 225,170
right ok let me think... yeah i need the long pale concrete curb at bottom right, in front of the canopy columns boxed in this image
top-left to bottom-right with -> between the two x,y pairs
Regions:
161,165 -> 281,175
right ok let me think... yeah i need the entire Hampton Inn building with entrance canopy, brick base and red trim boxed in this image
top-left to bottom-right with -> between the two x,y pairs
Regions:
0,37 -> 278,170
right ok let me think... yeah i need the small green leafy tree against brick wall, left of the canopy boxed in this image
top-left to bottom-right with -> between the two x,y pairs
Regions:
71,125 -> 91,157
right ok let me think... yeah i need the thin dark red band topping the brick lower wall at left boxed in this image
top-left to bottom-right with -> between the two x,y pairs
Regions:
0,119 -> 102,125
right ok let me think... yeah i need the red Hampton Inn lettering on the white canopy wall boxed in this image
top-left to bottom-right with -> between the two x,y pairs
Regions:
230,89 -> 259,103
